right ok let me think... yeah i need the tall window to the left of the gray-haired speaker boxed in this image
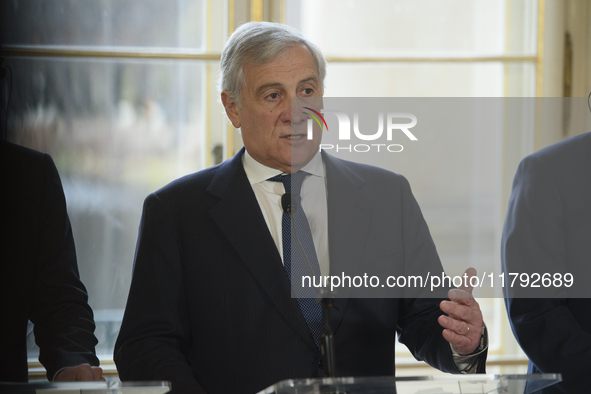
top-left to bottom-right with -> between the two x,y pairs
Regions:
0,0 -> 228,358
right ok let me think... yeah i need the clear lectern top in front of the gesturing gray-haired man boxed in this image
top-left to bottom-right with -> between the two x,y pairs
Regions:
258,374 -> 562,394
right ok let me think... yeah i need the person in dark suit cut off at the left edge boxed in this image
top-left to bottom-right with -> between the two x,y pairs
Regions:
0,141 -> 102,382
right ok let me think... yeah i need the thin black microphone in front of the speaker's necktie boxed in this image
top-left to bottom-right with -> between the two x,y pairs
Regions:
281,193 -> 336,378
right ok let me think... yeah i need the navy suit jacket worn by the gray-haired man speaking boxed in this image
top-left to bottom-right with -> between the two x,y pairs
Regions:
115,151 -> 484,394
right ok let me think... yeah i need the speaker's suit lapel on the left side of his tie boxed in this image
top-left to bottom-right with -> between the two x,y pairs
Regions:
207,148 -> 316,349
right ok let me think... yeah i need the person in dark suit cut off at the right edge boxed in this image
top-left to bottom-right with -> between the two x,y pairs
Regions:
501,133 -> 591,394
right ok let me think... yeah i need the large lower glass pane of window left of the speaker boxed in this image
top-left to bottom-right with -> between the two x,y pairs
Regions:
8,58 -> 215,357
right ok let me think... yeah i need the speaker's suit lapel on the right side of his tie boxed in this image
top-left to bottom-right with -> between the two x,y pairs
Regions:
323,154 -> 374,334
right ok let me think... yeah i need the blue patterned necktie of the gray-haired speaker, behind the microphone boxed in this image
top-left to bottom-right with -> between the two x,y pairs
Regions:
269,171 -> 322,346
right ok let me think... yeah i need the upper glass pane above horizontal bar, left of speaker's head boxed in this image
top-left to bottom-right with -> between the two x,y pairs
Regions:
0,0 -> 208,50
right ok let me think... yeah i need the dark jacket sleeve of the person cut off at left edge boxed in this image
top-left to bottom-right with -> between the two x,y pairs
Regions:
29,155 -> 99,380
